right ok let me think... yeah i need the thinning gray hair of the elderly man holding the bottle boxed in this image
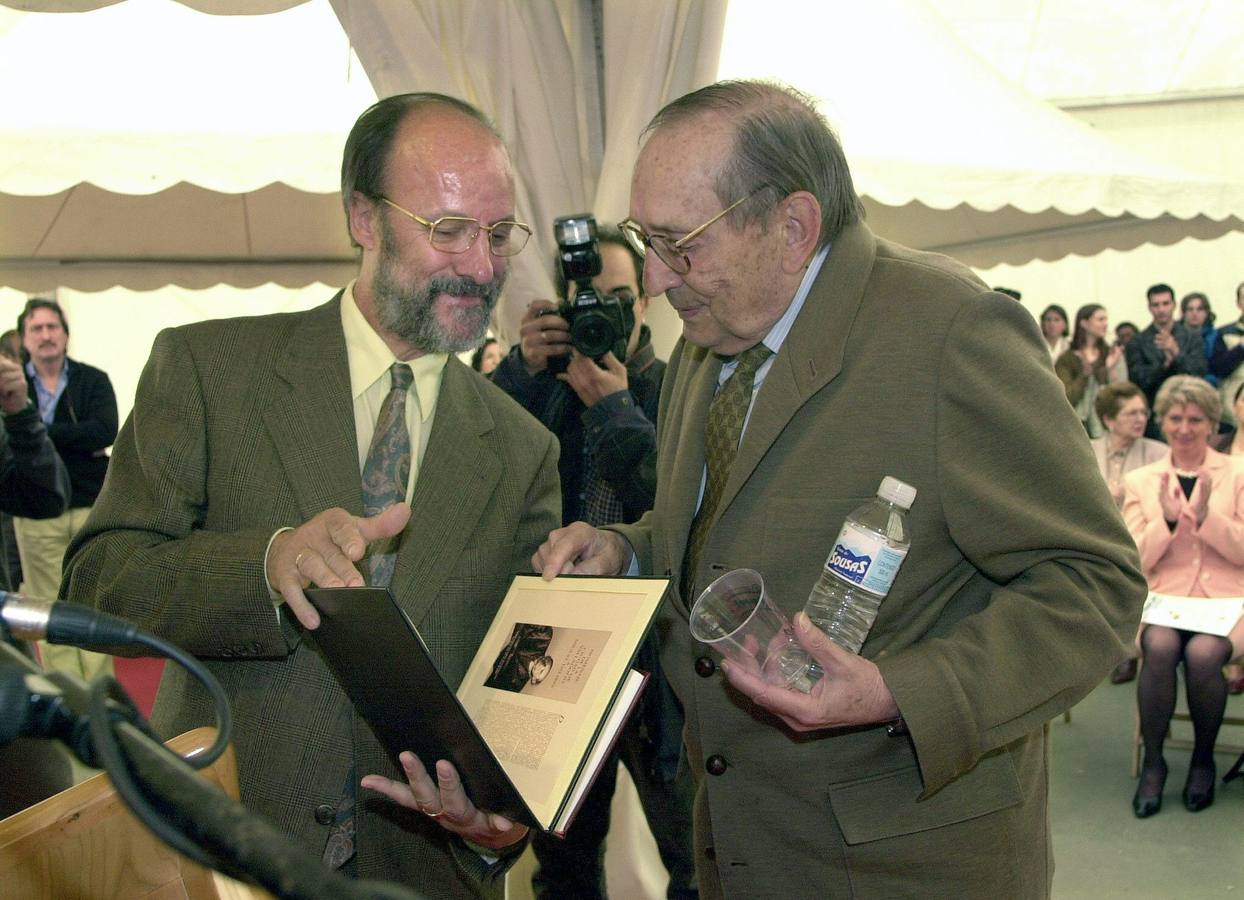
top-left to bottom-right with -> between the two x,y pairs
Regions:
643,81 -> 863,245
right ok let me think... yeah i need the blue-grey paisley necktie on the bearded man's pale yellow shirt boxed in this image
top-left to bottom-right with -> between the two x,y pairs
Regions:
363,362 -> 414,588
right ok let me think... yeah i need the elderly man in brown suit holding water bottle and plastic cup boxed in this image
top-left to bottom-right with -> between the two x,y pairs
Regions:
534,82 -> 1144,898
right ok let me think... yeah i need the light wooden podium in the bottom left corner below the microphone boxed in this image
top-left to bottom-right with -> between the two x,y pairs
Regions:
0,728 -> 271,900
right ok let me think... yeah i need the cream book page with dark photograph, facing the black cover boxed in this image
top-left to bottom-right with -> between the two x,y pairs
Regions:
458,575 -> 668,827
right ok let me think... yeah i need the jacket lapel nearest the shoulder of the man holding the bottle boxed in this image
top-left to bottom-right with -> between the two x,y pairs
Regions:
716,224 -> 877,525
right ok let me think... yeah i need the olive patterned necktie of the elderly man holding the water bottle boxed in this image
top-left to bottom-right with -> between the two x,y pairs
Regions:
683,344 -> 773,605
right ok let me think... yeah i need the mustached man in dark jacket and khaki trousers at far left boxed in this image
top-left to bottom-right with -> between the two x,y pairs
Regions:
14,298 -> 117,681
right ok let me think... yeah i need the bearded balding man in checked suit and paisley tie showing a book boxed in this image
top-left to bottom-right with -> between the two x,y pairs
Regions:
63,95 -> 561,898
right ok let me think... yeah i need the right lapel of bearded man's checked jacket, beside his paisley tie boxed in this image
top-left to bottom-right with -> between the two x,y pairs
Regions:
393,356 -> 503,624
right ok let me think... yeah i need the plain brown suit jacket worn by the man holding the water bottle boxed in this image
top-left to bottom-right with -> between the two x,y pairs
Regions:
607,224 -> 1144,899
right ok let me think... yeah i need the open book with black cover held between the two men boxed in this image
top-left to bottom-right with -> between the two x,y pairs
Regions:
306,575 -> 669,834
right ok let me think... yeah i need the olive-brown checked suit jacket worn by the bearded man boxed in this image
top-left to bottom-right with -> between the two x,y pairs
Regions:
61,295 -> 561,898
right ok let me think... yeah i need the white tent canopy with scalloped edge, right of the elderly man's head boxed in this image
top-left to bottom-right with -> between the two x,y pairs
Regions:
720,0 -> 1244,265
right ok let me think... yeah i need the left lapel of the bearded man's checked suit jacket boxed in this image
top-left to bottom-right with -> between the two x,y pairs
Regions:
262,294 -> 362,522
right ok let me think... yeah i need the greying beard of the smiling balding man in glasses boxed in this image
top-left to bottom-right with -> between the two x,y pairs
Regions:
372,228 -> 505,354
